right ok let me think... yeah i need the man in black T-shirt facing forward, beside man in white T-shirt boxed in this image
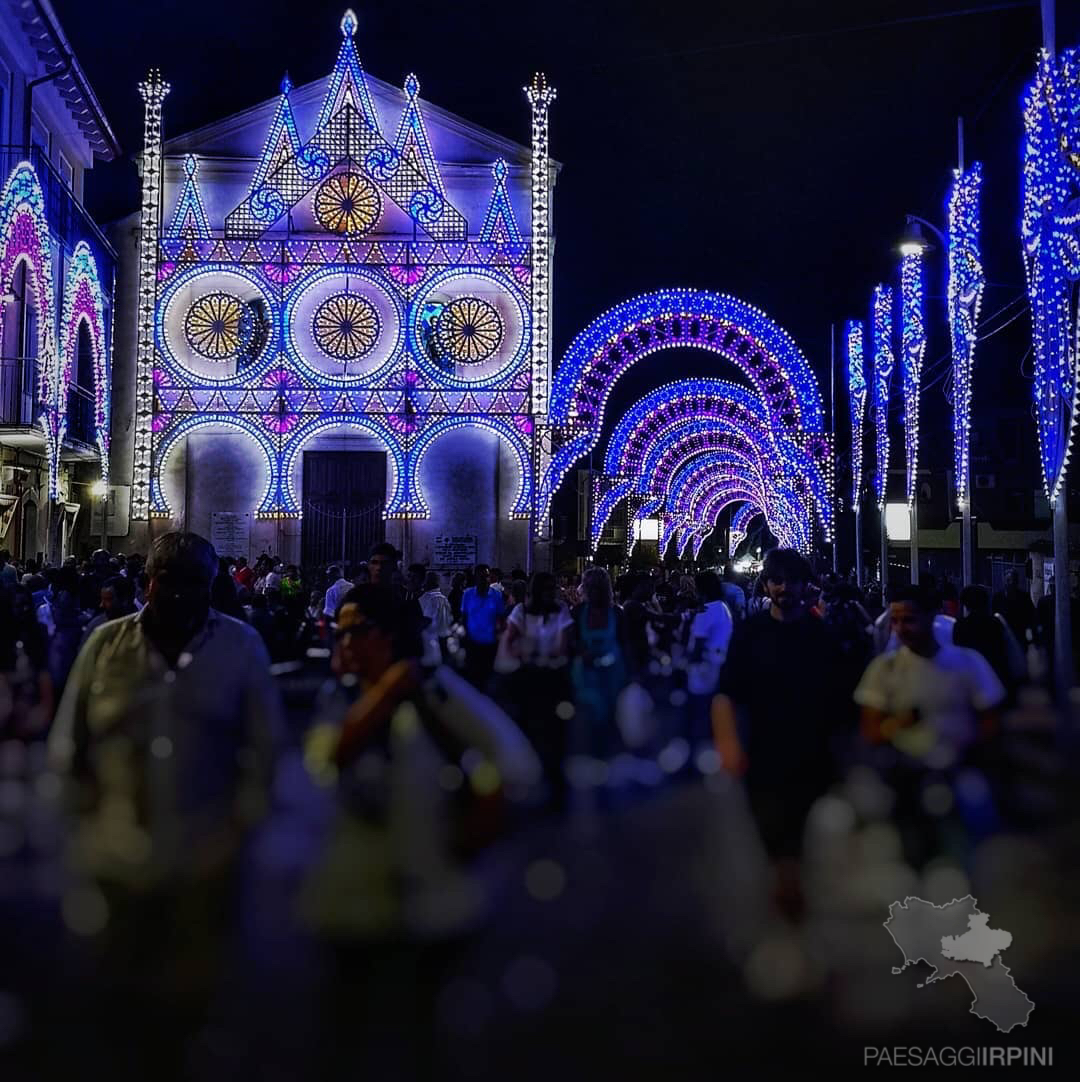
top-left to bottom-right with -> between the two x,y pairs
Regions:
712,549 -> 849,918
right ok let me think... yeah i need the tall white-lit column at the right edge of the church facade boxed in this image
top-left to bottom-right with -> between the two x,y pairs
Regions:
525,71 -> 555,571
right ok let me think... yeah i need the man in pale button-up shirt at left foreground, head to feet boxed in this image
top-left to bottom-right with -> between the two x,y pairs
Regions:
50,533 -> 280,1077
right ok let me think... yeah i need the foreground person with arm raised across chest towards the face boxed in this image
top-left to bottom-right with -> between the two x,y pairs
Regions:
301,584 -> 539,1079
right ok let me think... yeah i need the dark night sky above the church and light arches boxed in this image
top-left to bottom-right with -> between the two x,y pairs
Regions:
54,0 -> 1080,541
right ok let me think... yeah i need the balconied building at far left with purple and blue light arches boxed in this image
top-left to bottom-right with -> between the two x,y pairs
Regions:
0,0 -> 122,560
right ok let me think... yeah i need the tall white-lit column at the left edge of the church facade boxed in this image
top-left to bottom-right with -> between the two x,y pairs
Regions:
131,68 -> 171,519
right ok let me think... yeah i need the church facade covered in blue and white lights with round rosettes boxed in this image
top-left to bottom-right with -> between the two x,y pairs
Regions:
113,12 -> 556,568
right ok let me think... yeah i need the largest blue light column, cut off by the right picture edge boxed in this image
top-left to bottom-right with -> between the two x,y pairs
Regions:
1020,40 -> 1080,701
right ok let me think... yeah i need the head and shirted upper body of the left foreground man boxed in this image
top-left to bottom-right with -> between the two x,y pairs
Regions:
50,533 -> 280,878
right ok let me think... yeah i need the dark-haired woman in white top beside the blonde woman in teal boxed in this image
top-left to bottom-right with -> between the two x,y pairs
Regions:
497,571 -> 574,812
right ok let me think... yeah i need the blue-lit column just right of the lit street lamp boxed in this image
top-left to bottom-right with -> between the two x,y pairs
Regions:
947,162 -> 986,586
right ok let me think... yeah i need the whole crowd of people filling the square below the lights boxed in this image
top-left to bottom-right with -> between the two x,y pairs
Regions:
0,533 -> 1069,1076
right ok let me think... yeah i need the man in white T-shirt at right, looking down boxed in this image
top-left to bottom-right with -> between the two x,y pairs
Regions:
855,585 -> 1005,868
